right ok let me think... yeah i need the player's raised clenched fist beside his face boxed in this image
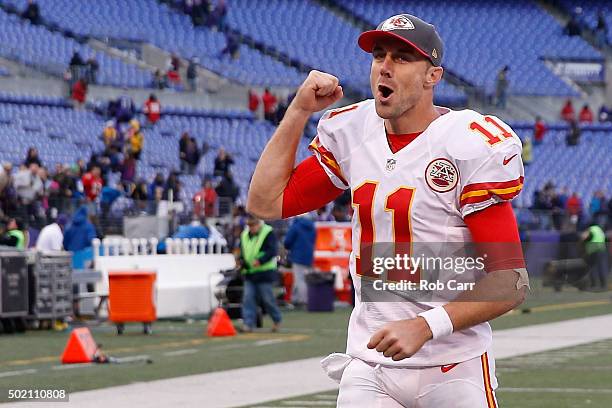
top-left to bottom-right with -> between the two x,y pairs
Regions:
291,70 -> 344,114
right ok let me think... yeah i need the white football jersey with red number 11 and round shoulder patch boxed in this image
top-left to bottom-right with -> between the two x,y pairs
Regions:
311,100 -> 524,367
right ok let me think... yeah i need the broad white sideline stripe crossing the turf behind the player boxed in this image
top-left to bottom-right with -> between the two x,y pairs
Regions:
2,314 -> 612,408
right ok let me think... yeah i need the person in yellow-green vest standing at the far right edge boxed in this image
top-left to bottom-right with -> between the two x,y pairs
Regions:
582,223 -> 609,290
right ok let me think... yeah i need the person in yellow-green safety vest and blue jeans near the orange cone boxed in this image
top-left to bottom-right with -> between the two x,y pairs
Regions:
239,215 -> 282,332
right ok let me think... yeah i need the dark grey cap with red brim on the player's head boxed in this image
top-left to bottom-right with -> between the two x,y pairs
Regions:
357,14 -> 443,67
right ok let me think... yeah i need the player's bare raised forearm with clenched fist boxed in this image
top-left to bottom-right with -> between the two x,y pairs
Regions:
247,71 -> 343,219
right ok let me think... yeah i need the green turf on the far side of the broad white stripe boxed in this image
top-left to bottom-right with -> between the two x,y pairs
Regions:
0,284 -> 612,406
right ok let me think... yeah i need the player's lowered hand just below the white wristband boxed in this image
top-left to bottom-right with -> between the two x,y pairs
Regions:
368,317 -> 433,361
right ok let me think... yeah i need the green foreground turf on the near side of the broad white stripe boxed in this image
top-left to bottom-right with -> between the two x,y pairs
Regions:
249,340 -> 612,408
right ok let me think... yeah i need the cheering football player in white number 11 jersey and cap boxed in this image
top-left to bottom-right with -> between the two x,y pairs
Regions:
247,14 -> 529,408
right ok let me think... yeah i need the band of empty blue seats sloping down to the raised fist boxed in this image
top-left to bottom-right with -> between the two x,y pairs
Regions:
2,0 -> 305,87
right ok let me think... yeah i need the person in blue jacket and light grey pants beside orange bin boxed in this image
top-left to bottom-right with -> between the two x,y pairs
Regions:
283,214 -> 317,306
